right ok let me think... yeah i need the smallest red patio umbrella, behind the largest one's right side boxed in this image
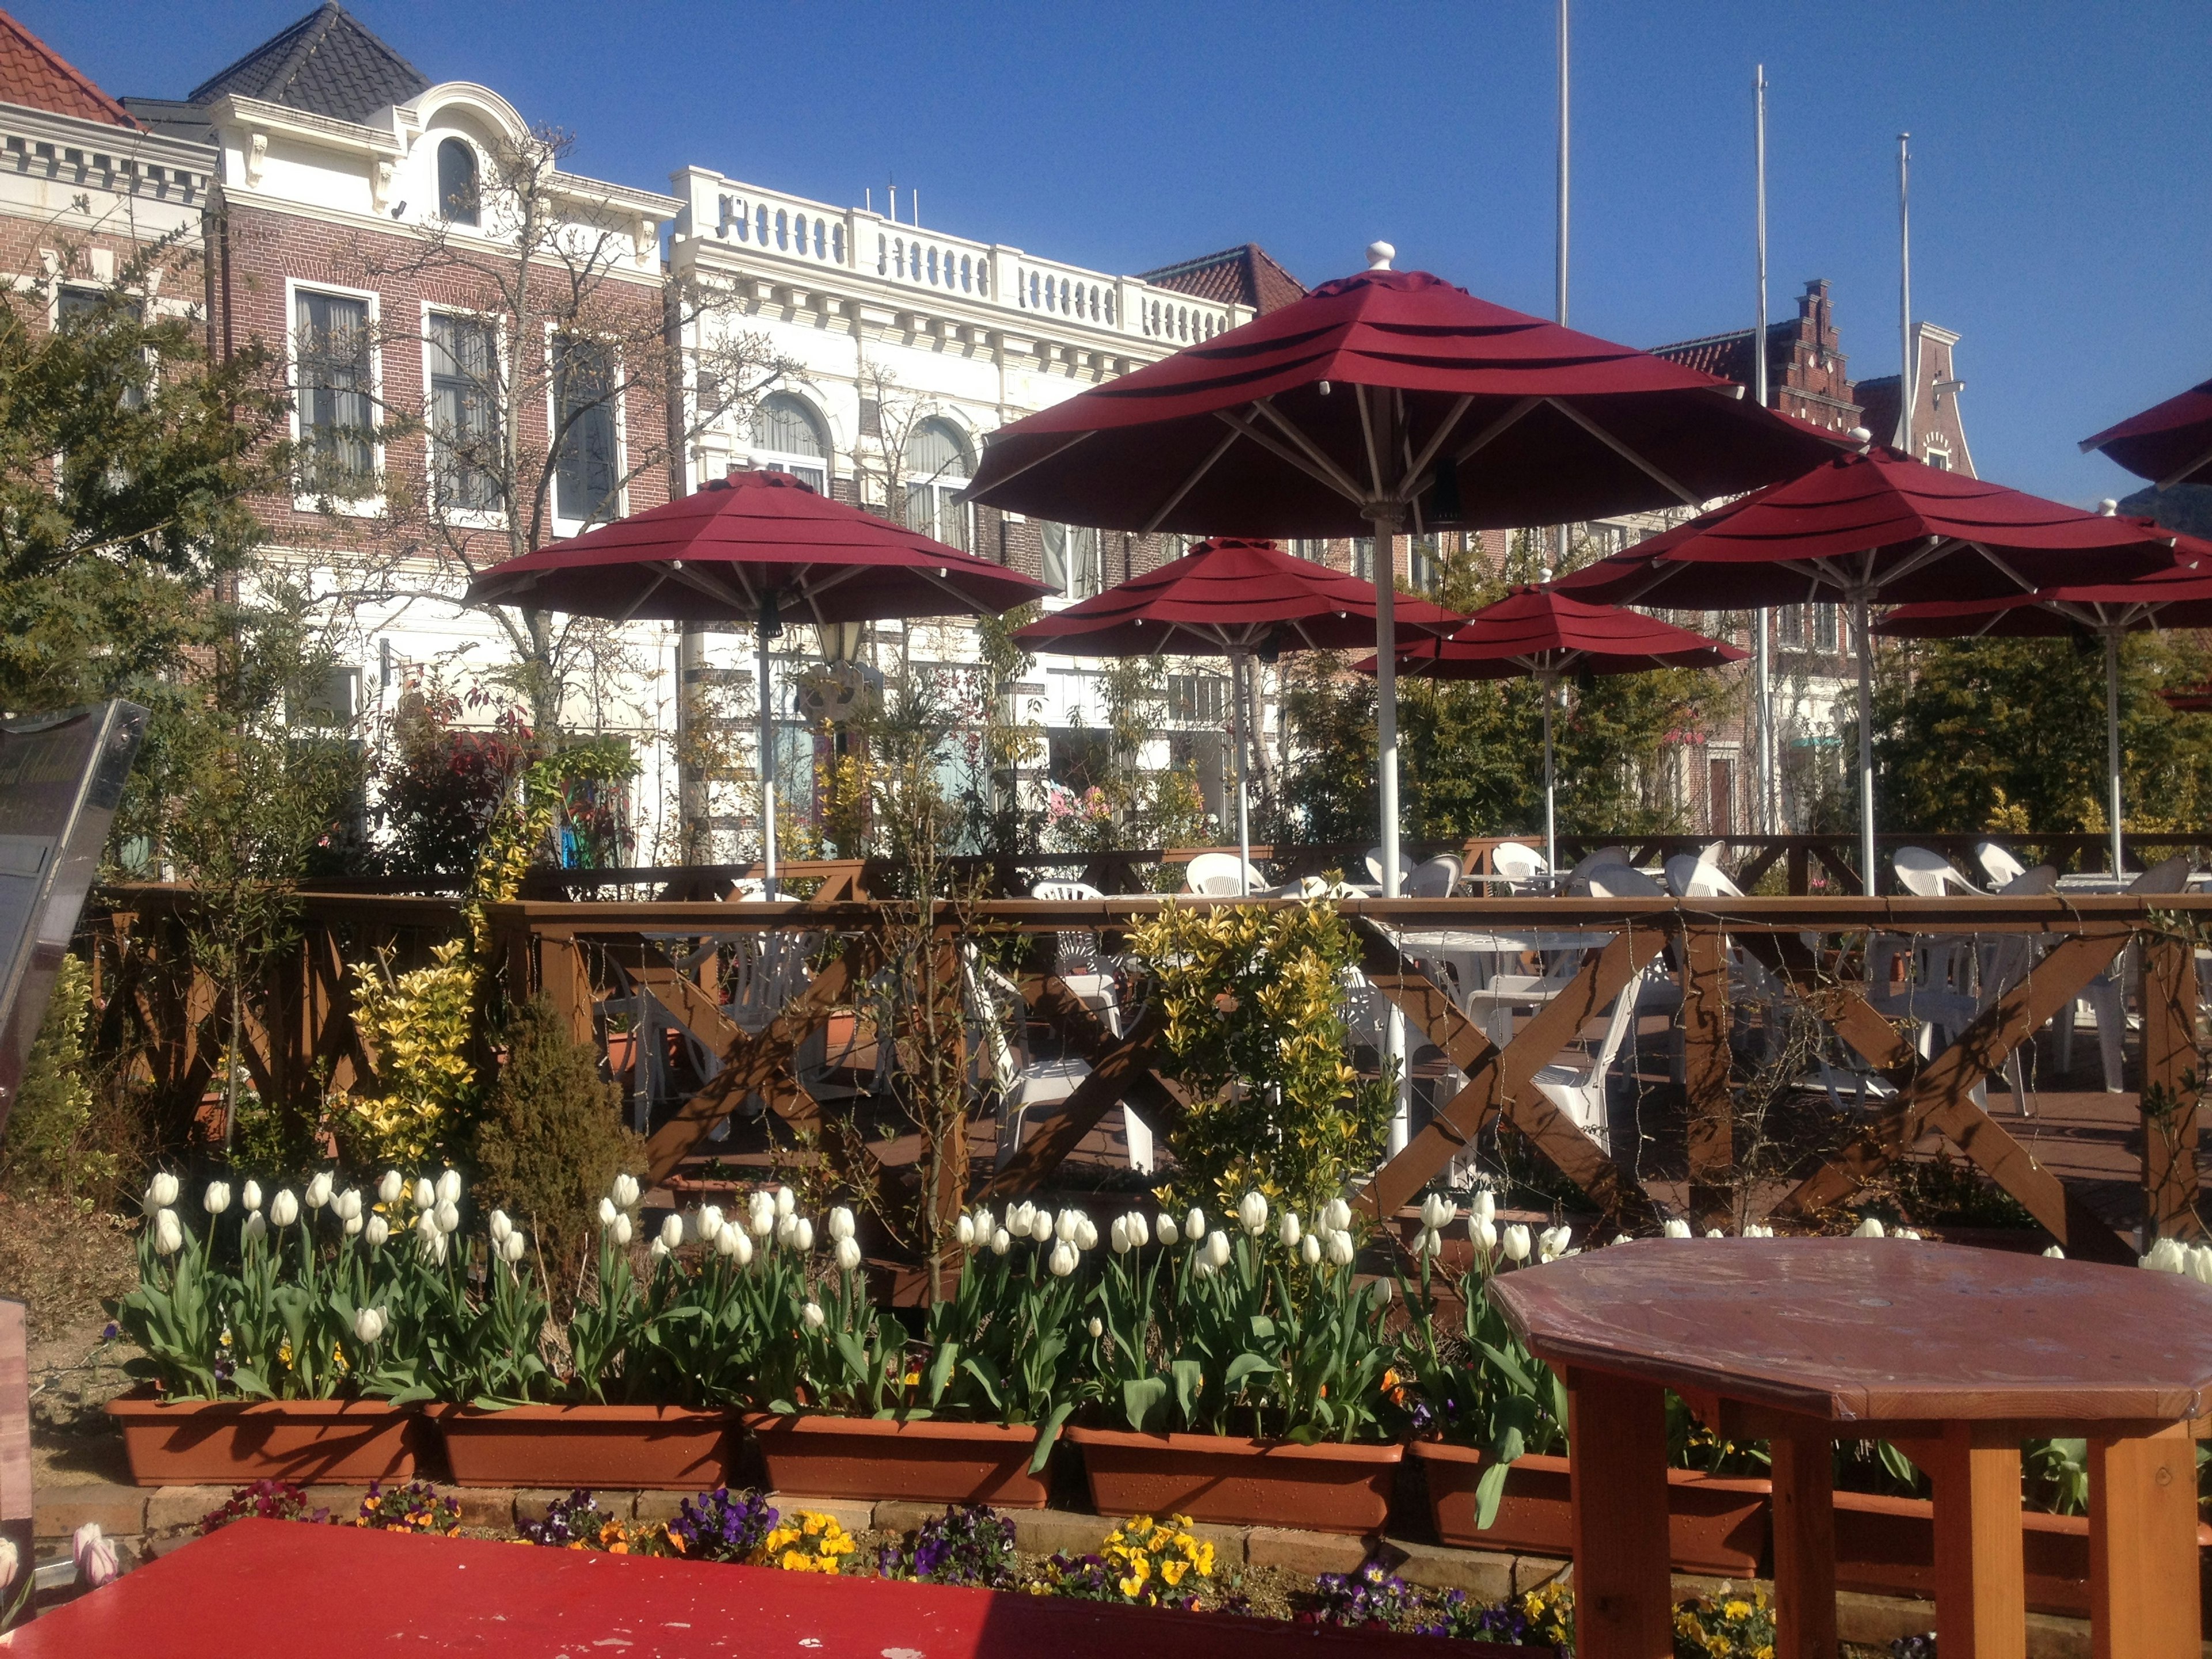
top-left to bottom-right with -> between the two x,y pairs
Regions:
1361,586 -> 1745,869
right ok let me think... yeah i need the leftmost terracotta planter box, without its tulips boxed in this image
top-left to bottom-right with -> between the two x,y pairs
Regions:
108,1387 -> 434,1486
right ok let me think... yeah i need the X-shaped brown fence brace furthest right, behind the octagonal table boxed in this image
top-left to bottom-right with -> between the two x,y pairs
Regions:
1774,927 -> 2135,1261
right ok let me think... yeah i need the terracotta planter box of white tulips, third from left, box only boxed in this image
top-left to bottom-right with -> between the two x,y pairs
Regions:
745,1411 -> 1051,1509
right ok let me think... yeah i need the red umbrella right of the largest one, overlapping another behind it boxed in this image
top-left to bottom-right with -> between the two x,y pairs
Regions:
1559,445 -> 2175,893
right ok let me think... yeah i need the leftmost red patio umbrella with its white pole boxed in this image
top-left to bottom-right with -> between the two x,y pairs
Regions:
469,471 -> 1048,892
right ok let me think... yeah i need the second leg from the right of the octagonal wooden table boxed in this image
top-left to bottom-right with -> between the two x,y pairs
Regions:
1900,1422 -> 2026,1659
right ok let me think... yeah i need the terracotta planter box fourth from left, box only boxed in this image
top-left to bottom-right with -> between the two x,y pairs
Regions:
1066,1429 -> 1404,1533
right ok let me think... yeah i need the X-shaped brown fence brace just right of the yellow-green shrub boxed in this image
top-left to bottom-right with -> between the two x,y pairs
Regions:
1356,922 -> 1666,1228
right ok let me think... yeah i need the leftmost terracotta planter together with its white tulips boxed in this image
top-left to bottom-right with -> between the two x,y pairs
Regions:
108,1172 -> 427,1486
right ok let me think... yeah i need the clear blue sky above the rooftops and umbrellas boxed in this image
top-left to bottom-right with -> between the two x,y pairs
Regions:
35,0 -> 2212,505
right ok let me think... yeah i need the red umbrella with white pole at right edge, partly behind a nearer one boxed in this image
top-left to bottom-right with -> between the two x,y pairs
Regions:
1873,546 -> 2212,876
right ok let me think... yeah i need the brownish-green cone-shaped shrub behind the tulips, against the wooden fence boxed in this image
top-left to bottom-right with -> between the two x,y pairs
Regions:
476,993 -> 646,1285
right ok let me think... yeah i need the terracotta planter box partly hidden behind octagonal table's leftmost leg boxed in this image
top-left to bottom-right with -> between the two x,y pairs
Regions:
1409,1440 -> 1772,1580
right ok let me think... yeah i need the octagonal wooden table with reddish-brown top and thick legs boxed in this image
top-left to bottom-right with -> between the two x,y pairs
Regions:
1491,1238 -> 2212,1659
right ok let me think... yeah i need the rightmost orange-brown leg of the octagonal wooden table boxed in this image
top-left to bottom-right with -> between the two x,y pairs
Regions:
2088,1422 -> 2203,1659
